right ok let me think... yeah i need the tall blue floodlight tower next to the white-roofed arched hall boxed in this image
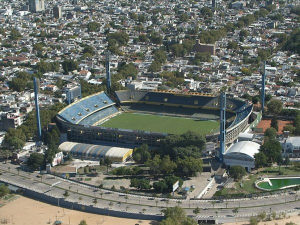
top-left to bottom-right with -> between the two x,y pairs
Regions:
219,92 -> 226,162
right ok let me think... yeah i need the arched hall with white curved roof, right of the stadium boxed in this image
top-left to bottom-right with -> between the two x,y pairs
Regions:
224,141 -> 260,172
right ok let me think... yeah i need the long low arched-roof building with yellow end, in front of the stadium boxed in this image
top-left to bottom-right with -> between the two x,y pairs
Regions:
59,142 -> 133,163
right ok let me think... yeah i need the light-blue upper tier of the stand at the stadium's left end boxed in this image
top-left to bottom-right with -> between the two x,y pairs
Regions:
57,92 -> 115,124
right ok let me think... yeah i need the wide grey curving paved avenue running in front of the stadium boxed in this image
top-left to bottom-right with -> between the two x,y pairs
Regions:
0,163 -> 300,222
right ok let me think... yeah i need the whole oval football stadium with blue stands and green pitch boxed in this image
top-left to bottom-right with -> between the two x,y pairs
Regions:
57,90 -> 253,149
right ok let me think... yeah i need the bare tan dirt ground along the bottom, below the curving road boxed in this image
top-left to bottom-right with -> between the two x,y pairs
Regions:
0,196 -> 300,225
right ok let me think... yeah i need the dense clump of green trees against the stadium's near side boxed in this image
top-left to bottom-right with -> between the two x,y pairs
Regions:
133,131 -> 206,176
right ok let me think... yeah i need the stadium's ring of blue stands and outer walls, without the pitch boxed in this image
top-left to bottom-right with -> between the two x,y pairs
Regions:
57,90 -> 253,149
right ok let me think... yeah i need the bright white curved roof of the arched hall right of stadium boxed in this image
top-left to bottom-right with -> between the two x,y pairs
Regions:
225,141 -> 260,159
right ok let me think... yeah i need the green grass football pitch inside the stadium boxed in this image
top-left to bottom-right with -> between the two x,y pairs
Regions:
100,113 -> 220,134
